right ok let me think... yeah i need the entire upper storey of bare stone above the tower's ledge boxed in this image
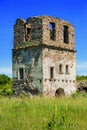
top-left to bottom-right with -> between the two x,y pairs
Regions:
14,16 -> 74,50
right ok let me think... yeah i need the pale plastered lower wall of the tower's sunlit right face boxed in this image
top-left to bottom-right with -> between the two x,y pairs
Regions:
43,48 -> 76,96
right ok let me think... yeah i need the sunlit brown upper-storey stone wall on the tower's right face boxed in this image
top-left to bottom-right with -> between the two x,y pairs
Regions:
43,17 -> 74,50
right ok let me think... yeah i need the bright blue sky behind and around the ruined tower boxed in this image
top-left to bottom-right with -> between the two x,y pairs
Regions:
0,0 -> 87,76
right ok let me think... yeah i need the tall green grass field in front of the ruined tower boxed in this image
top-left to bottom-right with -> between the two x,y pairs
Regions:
0,93 -> 87,130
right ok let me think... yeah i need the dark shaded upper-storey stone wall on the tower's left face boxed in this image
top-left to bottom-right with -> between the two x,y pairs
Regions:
14,17 -> 43,48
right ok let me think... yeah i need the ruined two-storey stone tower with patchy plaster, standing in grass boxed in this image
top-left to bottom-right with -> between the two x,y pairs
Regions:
12,16 -> 76,96
